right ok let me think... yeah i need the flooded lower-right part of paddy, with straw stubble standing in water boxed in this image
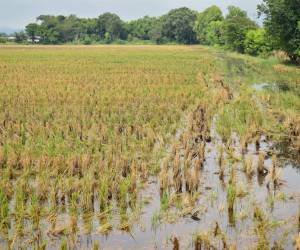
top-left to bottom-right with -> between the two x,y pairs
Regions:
0,117 -> 300,249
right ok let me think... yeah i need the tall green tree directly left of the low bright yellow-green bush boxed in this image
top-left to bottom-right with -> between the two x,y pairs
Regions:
223,6 -> 257,53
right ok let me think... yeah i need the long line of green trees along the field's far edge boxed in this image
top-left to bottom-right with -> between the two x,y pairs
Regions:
2,0 -> 300,62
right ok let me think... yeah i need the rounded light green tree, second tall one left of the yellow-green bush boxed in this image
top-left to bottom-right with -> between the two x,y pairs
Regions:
194,6 -> 224,44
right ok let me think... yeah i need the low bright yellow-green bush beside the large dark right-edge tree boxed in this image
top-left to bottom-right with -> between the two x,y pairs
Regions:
245,28 -> 272,56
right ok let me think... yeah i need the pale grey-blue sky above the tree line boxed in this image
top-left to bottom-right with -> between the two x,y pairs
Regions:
0,0 -> 261,31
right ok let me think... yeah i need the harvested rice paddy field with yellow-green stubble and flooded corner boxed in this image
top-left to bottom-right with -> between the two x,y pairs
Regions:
0,46 -> 300,250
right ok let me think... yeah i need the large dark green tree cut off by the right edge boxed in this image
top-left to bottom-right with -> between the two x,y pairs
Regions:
258,0 -> 300,62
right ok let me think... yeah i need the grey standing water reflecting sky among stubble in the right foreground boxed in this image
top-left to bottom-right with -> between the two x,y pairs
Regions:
4,122 -> 300,249
